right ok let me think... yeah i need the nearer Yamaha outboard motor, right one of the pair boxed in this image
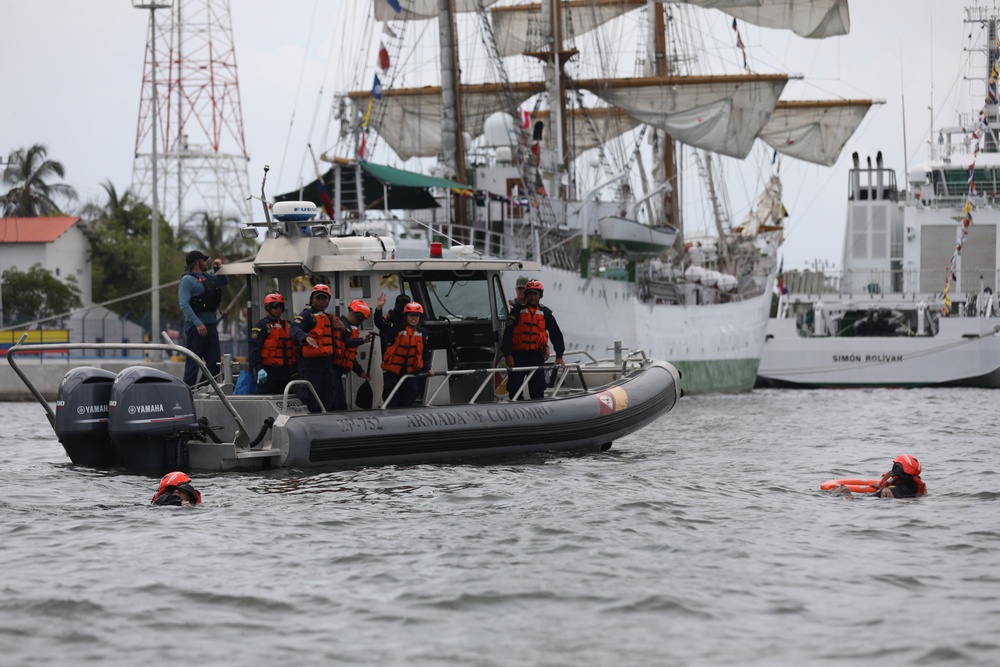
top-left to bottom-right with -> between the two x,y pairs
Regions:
108,366 -> 198,475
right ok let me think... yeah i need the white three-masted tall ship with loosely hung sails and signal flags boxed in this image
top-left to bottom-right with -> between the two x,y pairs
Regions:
288,0 -> 872,394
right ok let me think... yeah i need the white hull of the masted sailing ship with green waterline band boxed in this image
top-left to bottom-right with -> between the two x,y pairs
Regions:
541,267 -> 772,395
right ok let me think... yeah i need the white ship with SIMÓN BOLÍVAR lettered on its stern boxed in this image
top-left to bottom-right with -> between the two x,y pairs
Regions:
758,7 -> 1000,387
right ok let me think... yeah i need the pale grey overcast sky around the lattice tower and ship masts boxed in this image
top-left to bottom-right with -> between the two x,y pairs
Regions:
0,0 -> 992,268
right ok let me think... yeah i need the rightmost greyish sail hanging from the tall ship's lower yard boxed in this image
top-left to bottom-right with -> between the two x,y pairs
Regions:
759,100 -> 872,167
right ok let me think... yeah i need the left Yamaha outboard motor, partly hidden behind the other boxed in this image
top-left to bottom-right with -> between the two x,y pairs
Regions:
55,366 -> 118,468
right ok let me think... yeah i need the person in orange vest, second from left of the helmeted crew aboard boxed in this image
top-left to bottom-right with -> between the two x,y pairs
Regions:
290,283 -> 344,413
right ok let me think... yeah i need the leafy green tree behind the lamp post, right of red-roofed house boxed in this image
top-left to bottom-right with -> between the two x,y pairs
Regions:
83,181 -> 184,325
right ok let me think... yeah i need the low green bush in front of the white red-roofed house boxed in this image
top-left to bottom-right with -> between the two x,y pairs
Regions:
2,264 -> 83,329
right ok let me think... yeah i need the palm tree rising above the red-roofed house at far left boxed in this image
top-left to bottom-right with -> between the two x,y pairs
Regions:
0,144 -> 76,218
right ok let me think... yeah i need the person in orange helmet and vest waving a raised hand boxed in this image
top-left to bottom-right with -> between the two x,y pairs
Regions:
375,301 -> 434,408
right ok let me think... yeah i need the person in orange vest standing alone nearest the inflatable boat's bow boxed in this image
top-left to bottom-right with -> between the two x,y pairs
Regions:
500,280 -> 566,400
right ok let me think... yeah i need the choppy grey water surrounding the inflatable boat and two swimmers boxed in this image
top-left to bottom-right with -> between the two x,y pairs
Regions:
0,389 -> 1000,667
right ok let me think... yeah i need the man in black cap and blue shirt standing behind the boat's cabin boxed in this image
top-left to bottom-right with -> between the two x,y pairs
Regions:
180,250 -> 229,387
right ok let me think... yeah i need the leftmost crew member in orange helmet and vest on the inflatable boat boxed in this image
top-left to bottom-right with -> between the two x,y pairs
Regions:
248,292 -> 298,394
